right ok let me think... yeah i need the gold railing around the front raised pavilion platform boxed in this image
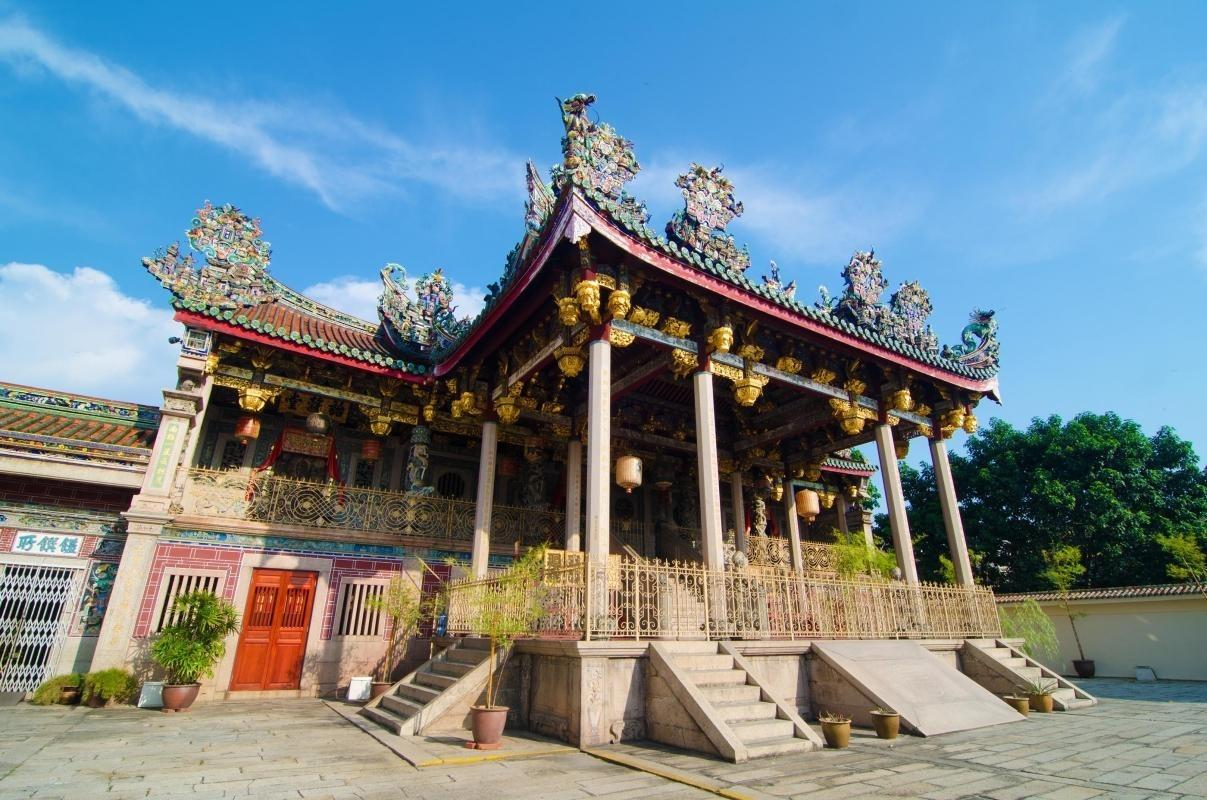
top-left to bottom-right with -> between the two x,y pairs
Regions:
449,559 -> 1002,640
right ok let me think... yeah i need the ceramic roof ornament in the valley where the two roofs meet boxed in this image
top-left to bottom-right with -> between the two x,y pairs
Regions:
378,264 -> 470,355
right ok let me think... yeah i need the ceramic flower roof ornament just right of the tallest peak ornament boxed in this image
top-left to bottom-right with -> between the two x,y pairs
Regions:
666,163 -> 751,273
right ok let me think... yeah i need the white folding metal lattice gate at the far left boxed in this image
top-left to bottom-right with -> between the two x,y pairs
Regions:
0,563 -> 84,691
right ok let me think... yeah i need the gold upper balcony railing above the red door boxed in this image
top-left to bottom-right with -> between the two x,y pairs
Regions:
182,469 -> 565,545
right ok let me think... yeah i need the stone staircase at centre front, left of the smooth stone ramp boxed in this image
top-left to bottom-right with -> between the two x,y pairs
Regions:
651,642 -> 822,761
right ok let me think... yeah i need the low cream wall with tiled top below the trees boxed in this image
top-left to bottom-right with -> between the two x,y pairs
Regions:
1018,594 -> 1207,681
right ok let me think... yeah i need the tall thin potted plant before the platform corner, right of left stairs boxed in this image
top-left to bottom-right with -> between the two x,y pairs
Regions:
470,545 -> 546,749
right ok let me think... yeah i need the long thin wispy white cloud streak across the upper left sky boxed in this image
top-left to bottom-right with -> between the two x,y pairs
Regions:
0,18 -> 524,210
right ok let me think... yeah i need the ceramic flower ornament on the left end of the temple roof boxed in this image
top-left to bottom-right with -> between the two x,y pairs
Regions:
142,202 -> 280,309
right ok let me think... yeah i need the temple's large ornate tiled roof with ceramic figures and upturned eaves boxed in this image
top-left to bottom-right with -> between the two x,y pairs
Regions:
142,94 -> 998,381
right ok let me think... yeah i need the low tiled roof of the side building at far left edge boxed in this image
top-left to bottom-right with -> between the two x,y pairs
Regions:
0,384 -> 159,463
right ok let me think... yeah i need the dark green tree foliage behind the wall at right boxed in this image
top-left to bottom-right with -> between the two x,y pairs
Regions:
881,413 -> 1207,591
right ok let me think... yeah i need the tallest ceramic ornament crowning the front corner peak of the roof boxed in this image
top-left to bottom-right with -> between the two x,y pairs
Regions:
553,94 -> 641,202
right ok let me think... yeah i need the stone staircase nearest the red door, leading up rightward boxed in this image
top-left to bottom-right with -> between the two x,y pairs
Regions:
360,638 -> 490,736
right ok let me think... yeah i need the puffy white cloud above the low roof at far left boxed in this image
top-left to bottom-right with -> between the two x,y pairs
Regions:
0,262 -> 181,405
